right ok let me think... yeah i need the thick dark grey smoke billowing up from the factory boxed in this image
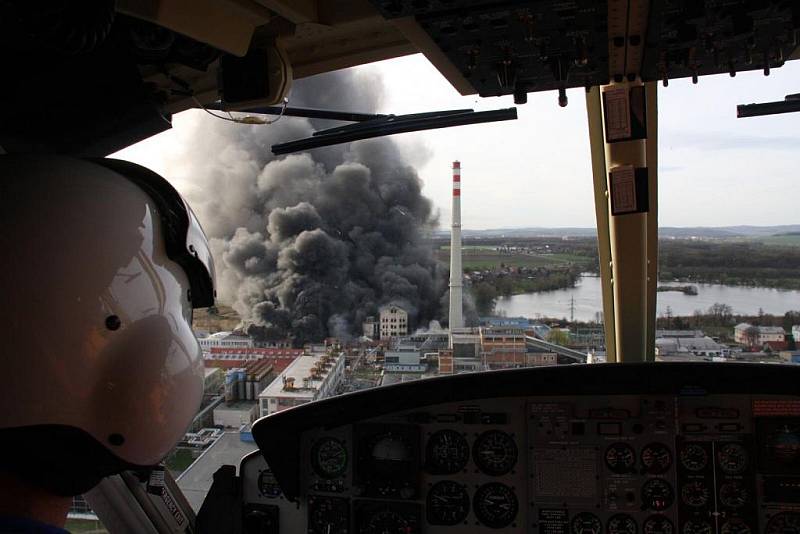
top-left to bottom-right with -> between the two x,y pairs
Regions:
169,70 -> 454,344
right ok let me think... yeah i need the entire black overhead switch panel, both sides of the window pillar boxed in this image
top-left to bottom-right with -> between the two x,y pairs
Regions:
370,0 -> 800,96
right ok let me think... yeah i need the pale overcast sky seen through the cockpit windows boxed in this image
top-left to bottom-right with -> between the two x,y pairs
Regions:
117,55 -> 800,229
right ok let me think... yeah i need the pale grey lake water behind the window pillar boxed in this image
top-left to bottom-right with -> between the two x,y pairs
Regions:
496,276 -> 800,321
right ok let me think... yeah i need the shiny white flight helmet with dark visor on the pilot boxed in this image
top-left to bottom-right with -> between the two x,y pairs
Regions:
0,155 -> 214,495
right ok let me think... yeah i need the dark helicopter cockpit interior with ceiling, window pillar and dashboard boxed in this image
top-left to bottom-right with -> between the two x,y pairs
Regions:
0,0 -> 800,534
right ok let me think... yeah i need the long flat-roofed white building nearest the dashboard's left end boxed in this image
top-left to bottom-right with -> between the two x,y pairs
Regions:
258,353 -> 345,417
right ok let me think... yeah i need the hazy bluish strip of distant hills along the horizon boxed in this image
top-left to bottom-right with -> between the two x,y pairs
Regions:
433,224 -> 800,238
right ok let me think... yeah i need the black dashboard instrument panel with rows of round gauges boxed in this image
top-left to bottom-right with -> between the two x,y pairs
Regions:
240,364 -> 800,534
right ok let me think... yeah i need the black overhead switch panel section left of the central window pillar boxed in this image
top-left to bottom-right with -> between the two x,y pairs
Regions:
374,0 -> 609,96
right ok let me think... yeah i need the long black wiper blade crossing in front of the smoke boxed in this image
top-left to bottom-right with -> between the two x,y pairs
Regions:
272,108 -> 517,156
